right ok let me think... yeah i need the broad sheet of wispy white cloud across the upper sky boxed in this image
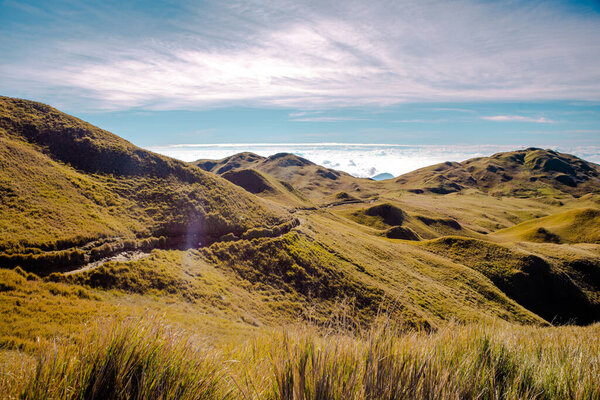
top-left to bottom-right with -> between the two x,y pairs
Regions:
0,0 -> 600,109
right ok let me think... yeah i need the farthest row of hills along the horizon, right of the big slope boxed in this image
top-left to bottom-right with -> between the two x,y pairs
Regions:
192,148 -> 600,205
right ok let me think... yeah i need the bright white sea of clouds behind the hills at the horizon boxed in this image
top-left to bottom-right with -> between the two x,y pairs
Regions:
148,143 -> 600,178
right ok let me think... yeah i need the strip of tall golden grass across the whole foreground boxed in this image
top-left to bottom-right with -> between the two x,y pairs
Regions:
0,321 -> 600,400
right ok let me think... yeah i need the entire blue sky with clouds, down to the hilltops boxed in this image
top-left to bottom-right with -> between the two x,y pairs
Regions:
0,0 -> 600,176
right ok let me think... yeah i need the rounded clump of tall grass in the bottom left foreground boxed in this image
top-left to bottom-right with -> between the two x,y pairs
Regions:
12,322 -> 227,399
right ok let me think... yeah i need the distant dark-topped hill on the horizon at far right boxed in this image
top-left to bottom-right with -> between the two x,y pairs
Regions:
396,148 -> 600,196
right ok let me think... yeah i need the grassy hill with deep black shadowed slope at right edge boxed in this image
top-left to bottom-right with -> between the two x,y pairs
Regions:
420,236 -> 600,324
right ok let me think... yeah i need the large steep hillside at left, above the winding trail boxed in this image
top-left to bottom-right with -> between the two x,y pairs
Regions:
0,97 -> 290,274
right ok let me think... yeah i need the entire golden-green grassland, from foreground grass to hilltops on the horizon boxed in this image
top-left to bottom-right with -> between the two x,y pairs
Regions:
0,98 -> 600,399
